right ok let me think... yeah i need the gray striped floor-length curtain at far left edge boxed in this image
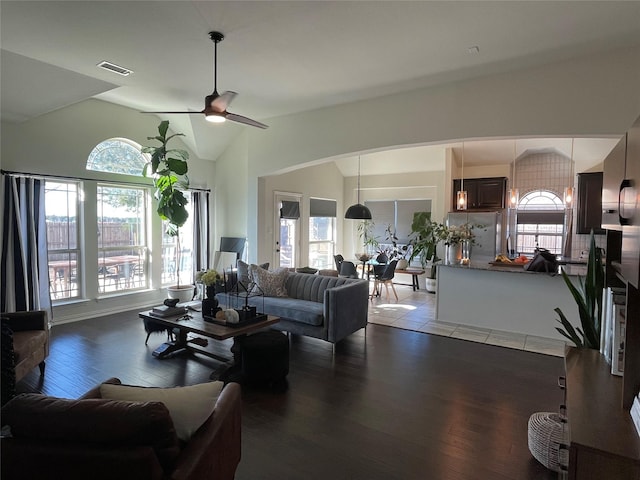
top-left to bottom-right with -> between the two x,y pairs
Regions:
0,175 -> 53,319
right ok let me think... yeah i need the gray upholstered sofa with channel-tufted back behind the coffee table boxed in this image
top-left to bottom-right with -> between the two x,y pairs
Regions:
216,272 -> 369,344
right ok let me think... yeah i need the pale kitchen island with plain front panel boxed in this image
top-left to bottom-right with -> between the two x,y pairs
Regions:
436,261 -> 586,340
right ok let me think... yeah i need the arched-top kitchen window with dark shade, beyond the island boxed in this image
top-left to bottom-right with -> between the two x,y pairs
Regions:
516,190 -> 565,255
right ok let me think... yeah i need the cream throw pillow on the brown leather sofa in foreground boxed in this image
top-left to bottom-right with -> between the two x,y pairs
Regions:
100,382 -> 224,442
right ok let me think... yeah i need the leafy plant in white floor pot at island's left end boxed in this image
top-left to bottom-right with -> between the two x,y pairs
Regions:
409,212 -> 444,293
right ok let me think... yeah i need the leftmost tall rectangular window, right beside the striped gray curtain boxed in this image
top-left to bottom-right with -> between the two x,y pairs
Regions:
45,180 -> 82,301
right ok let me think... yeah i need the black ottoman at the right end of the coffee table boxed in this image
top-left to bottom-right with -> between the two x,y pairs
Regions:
238,330 -> 289,389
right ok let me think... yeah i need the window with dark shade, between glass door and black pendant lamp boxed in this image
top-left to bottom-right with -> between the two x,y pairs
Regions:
309,198 -> 337,269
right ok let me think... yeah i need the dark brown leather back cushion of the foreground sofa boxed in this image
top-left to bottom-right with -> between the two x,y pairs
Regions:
2,393 -> 180,469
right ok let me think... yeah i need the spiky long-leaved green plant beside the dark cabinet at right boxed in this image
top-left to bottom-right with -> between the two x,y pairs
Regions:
554,231 -> 604,350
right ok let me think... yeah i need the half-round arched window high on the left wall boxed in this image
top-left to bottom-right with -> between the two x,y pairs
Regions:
87,138 -> 147,177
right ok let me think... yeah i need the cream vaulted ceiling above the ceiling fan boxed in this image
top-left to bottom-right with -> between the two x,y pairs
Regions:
0,1 -> 640,168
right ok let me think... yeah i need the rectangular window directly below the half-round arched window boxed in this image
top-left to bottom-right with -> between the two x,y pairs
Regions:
97,184 -> 148,294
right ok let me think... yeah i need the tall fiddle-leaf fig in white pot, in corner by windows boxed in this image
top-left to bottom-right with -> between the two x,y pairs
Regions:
141,120 -> 194,301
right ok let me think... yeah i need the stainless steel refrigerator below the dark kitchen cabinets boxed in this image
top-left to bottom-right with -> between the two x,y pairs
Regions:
447,211 -> 504,262
